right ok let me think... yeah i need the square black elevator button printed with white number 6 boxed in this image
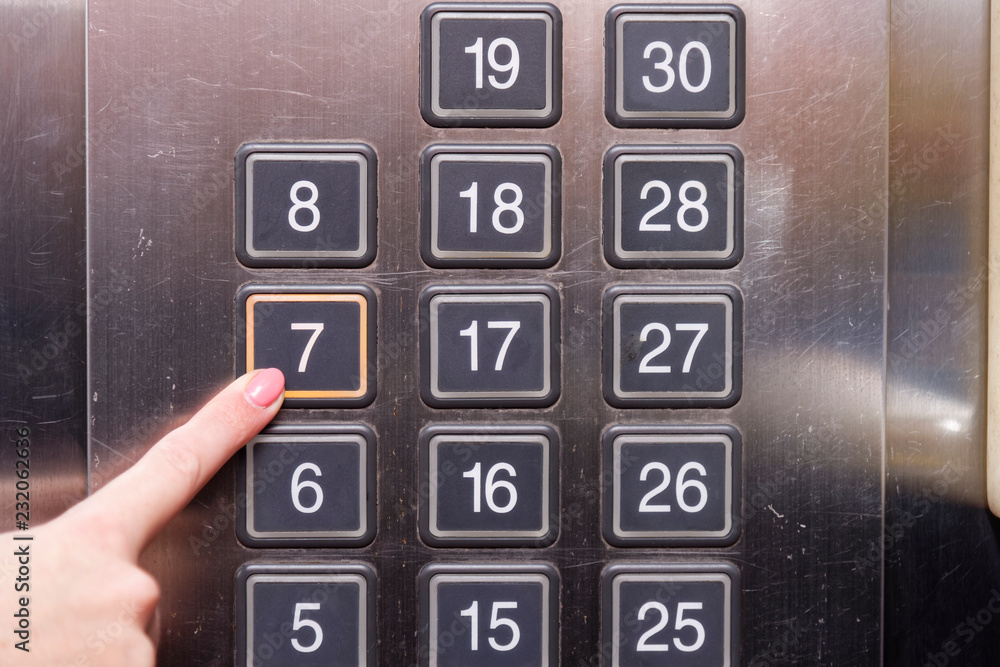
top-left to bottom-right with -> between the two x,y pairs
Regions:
236,424 -> 375,547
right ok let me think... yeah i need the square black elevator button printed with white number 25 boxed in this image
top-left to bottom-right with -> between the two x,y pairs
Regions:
602,563 -> 740,667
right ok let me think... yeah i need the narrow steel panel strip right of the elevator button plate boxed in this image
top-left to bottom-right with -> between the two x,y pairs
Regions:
885,0 -> 1000,665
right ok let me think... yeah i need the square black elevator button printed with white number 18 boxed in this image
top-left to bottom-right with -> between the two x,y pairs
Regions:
420,145 -> 561,267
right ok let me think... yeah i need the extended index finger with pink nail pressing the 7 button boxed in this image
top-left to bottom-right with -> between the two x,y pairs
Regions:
67,368 -> 285,557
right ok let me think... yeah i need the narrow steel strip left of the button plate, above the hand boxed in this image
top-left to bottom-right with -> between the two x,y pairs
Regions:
0,0 -> 87,540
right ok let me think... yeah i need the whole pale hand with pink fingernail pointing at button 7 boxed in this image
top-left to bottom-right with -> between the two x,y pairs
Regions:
0,370 -> 284,667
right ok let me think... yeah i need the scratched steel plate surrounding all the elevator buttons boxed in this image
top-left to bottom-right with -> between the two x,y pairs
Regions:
88,0 -> 888,666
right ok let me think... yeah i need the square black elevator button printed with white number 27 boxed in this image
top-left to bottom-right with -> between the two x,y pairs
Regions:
604,285 -> 743,407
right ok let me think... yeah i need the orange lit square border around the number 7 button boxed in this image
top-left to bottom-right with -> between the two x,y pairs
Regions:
238,285 -> 375,407
